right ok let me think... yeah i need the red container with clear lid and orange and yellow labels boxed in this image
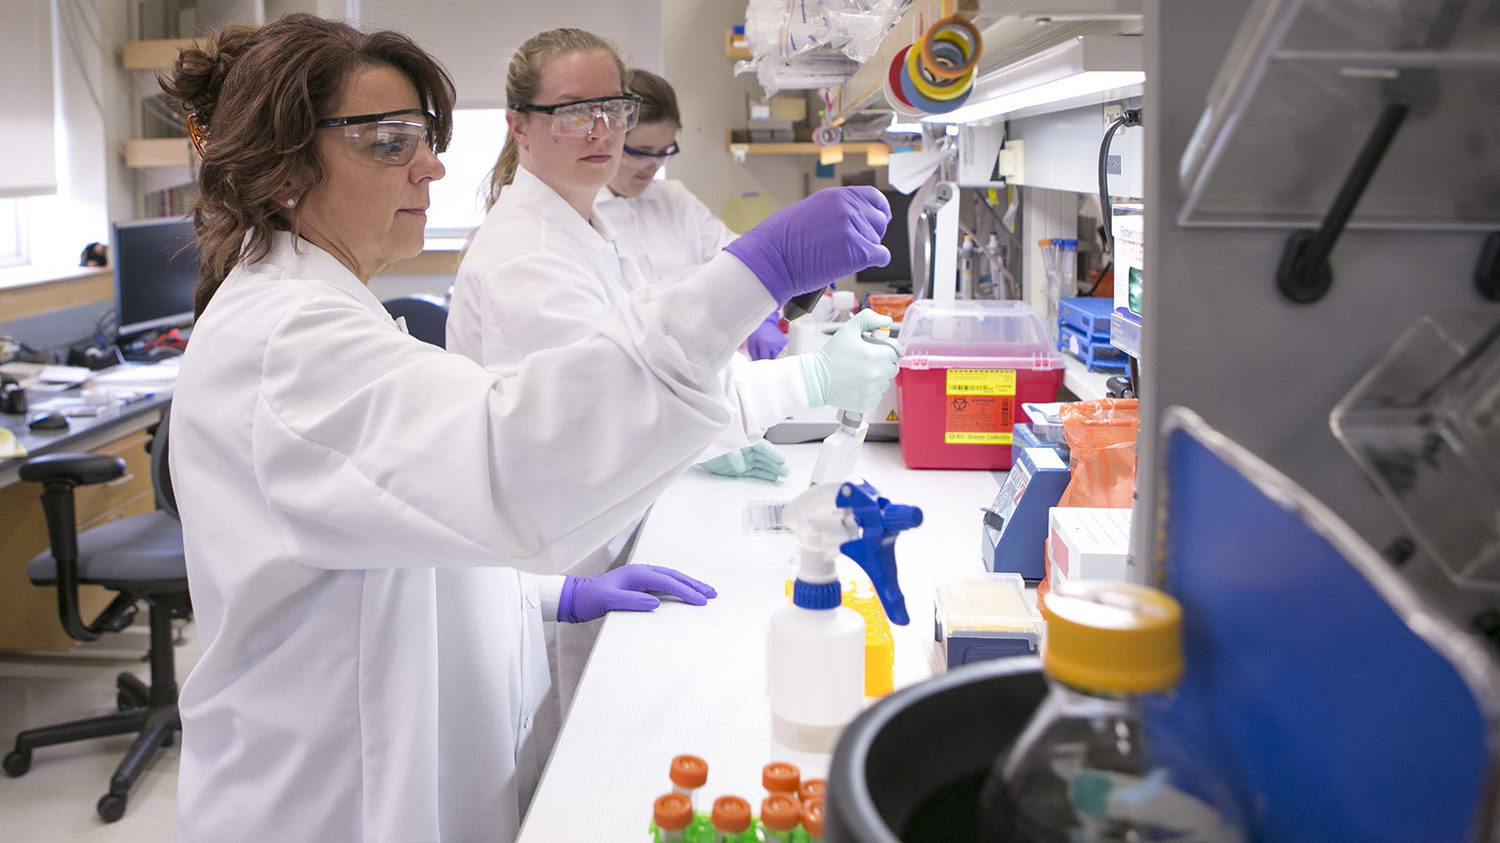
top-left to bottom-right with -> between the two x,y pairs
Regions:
896,300 -> 1064,470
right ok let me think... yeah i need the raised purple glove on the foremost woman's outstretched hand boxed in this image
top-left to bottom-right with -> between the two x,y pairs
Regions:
725,186 -> 891,308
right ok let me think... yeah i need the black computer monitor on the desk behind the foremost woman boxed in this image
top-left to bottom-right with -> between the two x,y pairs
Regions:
110,219 -> 198,338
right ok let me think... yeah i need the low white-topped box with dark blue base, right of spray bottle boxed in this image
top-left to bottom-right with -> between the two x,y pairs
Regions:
933,573 -> 1041,669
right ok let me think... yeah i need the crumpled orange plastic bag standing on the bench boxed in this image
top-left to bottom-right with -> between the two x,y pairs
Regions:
1058,398 -> 1140,507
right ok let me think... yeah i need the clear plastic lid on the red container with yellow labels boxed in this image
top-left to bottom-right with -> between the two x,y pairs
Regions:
902,299 -> 1062,369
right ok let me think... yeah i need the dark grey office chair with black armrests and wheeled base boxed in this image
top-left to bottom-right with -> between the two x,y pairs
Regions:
3,414 -> 192,822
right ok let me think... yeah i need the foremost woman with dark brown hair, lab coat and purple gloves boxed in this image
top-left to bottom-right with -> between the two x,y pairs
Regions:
162,15 -> 890,843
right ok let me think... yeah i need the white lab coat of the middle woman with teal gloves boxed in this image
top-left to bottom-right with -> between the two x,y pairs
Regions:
447,167 -> 809,459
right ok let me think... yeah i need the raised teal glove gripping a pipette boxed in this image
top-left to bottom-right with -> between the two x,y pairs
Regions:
800,311 -> 900,413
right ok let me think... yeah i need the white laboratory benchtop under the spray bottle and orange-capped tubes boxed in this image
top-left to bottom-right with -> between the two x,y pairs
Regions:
519,443 -> 1004,843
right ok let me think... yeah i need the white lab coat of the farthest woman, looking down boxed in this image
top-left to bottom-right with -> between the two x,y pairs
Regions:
594,179 -> 738,284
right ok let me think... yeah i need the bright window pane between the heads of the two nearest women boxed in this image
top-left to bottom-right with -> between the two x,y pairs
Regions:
428,108 -> 506,248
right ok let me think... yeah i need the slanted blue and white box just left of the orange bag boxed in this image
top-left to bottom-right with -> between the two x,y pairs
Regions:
980,447 -> 1070,582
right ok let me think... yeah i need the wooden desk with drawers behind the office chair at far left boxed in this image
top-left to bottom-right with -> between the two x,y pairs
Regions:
0,363 -> 173,653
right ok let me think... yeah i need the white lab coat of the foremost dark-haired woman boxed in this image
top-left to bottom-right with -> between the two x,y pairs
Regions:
171,233 -> 773,843
